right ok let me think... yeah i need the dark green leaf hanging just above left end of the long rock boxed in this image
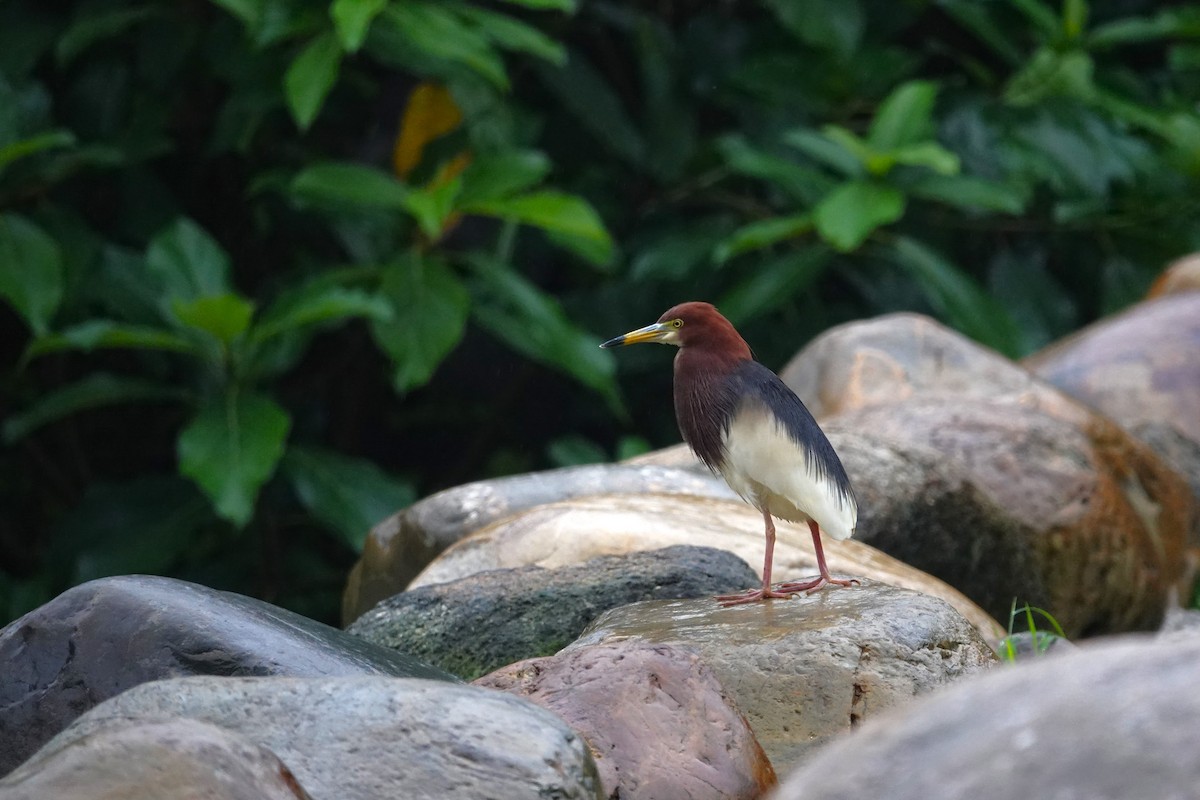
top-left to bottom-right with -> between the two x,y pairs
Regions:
283,447 -> 416,553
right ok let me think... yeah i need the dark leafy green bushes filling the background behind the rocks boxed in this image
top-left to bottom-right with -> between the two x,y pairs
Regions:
0,0 -> 1200,622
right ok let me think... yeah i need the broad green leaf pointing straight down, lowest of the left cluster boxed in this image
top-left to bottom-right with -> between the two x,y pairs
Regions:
178,389 -> 292,528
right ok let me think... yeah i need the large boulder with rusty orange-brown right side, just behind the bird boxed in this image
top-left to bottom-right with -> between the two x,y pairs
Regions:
826,396 -> 1198,638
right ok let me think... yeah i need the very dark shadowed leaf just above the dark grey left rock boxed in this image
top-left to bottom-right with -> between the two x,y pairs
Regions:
50,475 -> 212,584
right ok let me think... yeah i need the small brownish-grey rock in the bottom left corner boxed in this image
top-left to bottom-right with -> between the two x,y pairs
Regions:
0,720 -> 310,800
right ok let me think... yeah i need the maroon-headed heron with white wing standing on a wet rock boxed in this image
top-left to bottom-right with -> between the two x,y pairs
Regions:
600,302 -> 859,606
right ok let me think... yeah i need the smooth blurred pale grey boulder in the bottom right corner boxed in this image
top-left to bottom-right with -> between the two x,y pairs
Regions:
770,636 -> 1200,800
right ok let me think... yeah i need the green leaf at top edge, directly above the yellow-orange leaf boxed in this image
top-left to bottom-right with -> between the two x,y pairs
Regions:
380,0 -> 509,89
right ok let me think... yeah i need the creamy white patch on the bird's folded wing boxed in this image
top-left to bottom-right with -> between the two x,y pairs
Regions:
721,408 -> 858,539
